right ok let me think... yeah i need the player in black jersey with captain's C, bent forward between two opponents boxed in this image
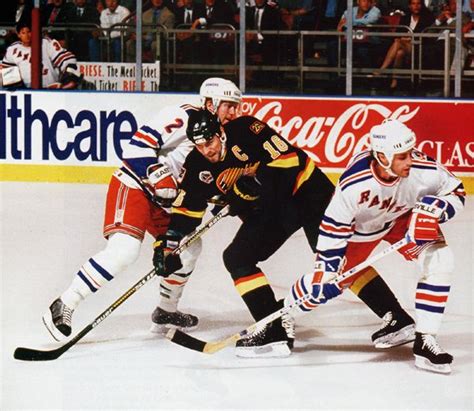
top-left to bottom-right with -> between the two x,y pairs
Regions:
153,110 -> 414,357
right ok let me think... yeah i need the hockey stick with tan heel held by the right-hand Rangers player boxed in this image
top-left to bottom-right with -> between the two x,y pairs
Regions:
166,237 -> 410,354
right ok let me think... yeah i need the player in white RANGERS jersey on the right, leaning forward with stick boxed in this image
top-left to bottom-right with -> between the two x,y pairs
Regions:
287,119 -> 465,373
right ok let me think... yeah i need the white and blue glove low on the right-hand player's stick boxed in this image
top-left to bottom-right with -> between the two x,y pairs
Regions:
285,261 -> 342,312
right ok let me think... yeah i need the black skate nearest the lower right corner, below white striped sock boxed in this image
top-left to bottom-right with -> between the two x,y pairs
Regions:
413,333 -> 453,374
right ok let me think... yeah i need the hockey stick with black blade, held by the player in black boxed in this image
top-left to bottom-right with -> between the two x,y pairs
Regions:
13,206 -> 229,361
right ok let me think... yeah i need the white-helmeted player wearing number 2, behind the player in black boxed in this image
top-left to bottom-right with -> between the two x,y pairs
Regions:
43,78 -> 241,341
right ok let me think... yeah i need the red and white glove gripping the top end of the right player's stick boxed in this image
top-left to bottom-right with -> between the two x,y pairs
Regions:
408,196 -> 449,245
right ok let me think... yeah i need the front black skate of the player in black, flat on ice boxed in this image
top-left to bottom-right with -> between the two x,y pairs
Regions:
235,320 -> 293,358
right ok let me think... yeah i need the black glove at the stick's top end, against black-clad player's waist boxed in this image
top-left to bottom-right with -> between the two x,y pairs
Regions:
226,176 -> 261,216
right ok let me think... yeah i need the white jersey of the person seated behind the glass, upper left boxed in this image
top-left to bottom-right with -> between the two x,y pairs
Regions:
2,37 -> 76,88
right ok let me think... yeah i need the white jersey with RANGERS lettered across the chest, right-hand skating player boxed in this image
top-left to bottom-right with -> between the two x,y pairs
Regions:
317,150 -> 465,270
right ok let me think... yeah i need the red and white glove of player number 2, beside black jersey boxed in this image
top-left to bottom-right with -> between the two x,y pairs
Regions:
144,164 -> 178,208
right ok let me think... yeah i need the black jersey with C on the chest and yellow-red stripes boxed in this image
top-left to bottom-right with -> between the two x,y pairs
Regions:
169,116 -> 330,234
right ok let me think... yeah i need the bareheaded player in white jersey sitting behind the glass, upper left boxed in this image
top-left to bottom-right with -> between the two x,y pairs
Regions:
2,19 -> 81,89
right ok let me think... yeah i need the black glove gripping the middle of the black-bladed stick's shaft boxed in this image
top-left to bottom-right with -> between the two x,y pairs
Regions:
153,230 -> 183,278
